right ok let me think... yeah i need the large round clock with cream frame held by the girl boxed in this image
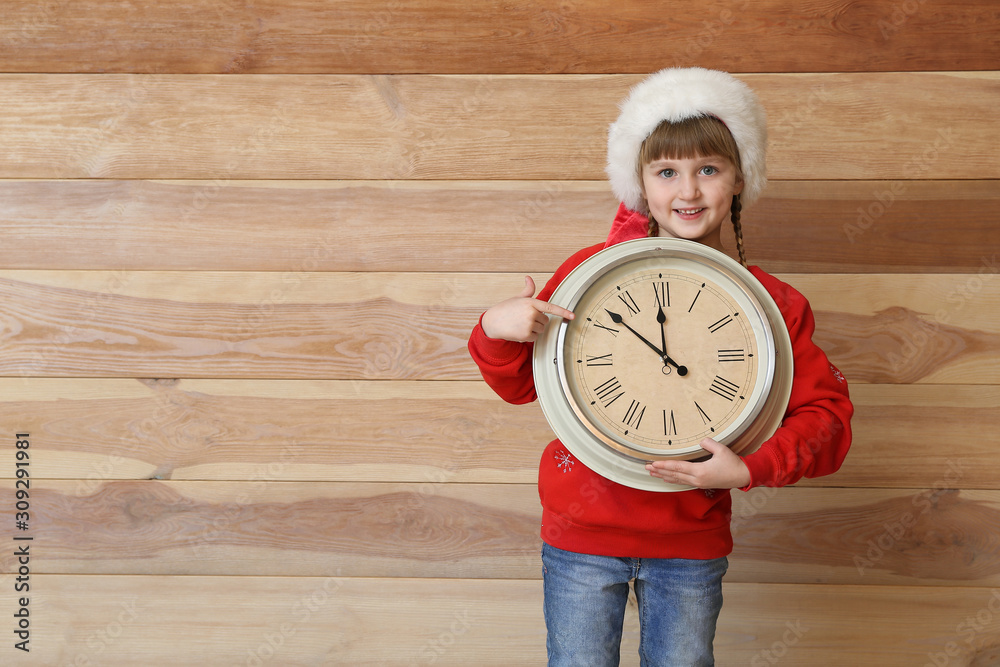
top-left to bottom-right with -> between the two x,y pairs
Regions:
533,238 -> 793,491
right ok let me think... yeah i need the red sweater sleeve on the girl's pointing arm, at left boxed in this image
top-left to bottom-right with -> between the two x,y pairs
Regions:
469,243 -> 604,404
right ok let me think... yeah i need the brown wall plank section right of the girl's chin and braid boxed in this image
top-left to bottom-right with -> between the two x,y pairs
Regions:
748,181 -> 1000,273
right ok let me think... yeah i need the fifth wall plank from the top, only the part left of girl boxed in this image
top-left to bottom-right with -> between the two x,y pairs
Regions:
0,379 -> 551,490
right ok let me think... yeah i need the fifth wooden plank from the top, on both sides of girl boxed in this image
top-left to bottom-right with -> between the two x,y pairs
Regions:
0,378 -> 1000,495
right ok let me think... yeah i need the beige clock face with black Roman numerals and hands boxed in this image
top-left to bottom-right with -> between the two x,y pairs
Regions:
562,259 -> 769,460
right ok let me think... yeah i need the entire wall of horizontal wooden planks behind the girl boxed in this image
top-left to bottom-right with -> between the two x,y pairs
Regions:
0,0 -> 1000,666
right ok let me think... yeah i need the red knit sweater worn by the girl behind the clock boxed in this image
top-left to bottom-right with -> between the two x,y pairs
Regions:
469,243 -> 854,559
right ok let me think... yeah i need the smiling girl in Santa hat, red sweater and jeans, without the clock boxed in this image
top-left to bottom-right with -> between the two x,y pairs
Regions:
469,68 -> 853,667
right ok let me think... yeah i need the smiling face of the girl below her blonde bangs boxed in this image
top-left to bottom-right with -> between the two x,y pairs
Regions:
642,155 -> 743,250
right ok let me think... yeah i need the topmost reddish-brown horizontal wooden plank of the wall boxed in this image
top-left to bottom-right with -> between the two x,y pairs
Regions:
0,0 -> 1000,74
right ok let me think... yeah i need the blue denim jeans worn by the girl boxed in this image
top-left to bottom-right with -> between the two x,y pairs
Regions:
542,544 -> 729,667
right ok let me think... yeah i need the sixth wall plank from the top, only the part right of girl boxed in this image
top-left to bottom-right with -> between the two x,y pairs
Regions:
727,486 -> 1000,586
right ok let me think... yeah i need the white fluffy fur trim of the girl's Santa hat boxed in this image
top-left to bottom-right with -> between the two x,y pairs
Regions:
607,67 -> 767,211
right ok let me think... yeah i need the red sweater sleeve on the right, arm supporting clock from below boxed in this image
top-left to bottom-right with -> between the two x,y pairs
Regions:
743,271 -> 854,491
